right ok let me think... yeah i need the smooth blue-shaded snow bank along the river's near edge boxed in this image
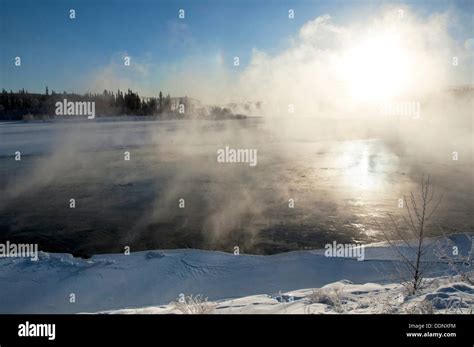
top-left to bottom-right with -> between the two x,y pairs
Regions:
0,234 -> 473,313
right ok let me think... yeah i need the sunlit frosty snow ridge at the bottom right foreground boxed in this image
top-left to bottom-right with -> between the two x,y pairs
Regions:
103,278 -> 474,314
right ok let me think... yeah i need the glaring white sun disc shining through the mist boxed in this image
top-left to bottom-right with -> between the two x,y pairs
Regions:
342,33 -> 409,102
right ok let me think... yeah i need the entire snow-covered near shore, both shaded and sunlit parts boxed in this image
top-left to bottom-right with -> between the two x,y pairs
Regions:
0,234 -> 474,313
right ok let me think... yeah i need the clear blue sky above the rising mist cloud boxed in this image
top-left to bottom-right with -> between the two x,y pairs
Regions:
0,0 -> 474,92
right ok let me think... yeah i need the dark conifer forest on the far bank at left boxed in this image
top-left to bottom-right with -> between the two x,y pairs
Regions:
0,87 -> 183,120
